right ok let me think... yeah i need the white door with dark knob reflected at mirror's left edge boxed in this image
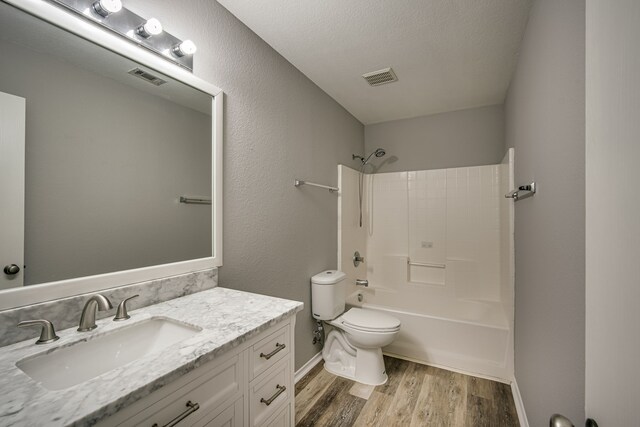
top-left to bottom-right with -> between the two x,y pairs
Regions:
0,92 -> 26,290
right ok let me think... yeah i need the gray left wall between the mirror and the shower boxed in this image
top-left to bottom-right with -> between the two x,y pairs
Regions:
127,0 -> 364,367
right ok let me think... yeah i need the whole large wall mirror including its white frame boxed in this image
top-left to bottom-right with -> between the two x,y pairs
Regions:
0,0 -> 222,309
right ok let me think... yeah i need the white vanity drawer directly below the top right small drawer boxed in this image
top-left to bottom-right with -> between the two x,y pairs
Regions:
249,357 -> 293,426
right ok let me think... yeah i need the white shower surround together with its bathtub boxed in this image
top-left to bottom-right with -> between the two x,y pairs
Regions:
338,149 -> 513,382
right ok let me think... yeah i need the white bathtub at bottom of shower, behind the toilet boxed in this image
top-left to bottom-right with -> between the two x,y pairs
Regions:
347,289 -> 511,383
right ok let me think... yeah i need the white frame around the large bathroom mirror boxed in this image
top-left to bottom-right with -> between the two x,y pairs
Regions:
0,0 -> 224,310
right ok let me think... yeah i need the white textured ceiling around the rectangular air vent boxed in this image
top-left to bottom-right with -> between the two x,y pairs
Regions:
218,0 -> 531,124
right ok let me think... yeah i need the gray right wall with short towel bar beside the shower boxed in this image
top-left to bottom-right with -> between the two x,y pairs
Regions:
505,0 -> 585,426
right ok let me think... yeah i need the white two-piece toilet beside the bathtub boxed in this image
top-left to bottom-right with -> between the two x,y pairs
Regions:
311,270 -> 400,385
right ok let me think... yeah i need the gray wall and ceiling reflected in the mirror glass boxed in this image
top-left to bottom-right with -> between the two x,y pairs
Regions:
0,4 -> 212,285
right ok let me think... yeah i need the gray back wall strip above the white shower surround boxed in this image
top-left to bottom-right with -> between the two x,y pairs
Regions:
365,105 -> 505,172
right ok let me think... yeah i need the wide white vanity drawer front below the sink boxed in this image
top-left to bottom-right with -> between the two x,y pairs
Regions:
121,354 -> 244,427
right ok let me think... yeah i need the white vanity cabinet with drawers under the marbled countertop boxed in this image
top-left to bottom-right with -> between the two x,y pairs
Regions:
98,315 -> 295,427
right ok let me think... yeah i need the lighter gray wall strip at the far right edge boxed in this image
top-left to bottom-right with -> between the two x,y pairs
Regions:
585,0 -> 640,426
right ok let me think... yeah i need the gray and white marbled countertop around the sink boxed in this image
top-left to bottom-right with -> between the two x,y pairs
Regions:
0,287 -> 302,426
